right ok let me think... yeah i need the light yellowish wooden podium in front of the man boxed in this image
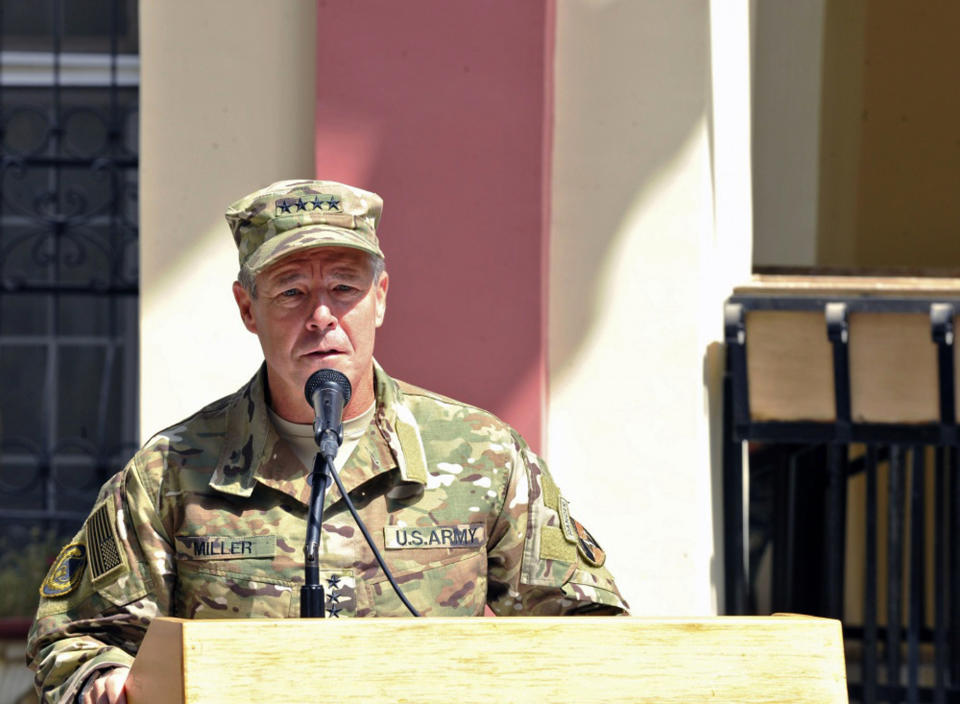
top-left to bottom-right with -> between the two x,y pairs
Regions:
127,616 -> 847,704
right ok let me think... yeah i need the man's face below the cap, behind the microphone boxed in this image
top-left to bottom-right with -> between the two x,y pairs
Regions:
233,247 -> 388,423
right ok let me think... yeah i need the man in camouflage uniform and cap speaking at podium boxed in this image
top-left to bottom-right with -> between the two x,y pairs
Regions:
28,181 -> 626,702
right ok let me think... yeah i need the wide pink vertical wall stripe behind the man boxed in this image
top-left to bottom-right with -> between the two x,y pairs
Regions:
316,0 -> 554,449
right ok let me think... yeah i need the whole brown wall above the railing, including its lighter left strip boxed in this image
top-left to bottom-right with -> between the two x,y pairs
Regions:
817,0 -> 960,270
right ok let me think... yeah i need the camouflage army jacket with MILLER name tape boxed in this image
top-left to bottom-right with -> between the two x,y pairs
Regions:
27,366 -> 626,701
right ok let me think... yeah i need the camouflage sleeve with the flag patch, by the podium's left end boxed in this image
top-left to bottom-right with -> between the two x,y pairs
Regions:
27,454 -> 174,702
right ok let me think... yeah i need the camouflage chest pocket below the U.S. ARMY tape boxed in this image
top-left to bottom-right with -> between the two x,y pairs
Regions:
367,549 -> 487,616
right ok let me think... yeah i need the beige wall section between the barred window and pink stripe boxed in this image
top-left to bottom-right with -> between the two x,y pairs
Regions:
140,0 -> 316,440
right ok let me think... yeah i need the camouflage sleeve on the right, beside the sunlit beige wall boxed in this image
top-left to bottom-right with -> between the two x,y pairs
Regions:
487,435 -> 628,616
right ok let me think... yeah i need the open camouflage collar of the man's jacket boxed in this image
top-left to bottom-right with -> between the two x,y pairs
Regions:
209,361 -> 427,504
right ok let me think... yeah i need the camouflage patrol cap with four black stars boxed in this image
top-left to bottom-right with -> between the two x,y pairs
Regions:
225,180 -> 383,273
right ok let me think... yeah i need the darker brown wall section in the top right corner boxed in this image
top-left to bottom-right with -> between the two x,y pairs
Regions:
856,0 -> 960,269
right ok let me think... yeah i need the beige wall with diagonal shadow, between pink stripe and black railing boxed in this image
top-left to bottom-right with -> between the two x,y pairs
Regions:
547,0 -> 751,614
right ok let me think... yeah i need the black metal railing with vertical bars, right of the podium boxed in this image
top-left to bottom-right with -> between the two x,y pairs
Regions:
724,293 -> 960,702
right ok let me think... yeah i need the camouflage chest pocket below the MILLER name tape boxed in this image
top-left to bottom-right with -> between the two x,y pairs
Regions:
174,560 -> 296,618
